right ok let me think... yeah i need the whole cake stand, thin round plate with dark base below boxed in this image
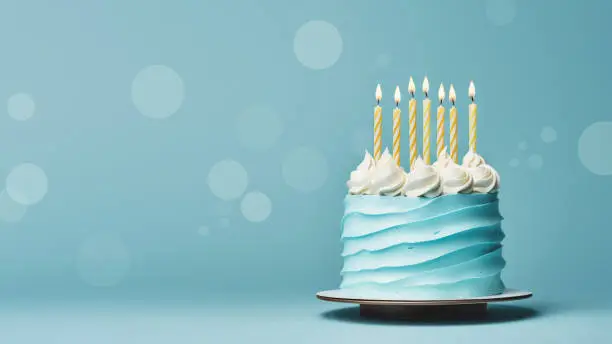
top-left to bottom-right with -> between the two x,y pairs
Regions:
317,289 -> 533,319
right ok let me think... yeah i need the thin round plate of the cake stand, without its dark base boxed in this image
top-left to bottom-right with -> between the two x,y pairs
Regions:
316,289 -> 533,306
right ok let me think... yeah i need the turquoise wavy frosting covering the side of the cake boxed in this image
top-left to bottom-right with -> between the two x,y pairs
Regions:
340,194 -> 506,299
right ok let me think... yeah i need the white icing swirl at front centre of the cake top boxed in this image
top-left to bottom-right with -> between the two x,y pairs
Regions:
402,157 -> 442,198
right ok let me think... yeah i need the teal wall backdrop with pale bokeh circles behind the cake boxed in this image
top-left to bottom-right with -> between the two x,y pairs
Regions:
0,0 -> 612,300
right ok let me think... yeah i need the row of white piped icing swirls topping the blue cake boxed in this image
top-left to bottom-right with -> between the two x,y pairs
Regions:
347,150 -> 500,198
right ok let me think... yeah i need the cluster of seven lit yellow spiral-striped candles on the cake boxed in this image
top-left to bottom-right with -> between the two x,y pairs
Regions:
374,77 -> 478,169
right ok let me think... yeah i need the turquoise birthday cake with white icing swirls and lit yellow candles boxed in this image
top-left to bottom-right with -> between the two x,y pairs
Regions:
340,80 -> 506,300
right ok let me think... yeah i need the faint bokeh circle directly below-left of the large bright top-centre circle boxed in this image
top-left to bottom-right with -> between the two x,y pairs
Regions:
236,105 -> 283,151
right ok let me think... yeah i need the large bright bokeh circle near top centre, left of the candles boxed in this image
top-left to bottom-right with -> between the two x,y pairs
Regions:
293,20 -> 342,69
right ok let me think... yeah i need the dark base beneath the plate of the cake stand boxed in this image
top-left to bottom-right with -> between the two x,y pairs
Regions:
359,303 -> 487,320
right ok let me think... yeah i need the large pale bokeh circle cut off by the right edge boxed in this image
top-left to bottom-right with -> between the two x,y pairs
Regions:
578,122 -> 612,176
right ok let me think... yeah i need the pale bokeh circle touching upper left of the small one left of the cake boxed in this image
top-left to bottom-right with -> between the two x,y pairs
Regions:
208,159 -> 249,201
